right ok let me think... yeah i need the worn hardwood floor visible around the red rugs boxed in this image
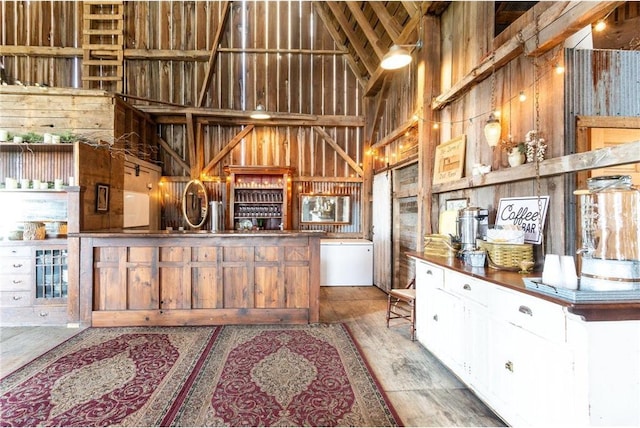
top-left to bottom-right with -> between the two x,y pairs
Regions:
0,287 -> 504,426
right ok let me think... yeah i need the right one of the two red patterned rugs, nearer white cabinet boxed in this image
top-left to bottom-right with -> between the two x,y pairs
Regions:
170,324 -> 400,426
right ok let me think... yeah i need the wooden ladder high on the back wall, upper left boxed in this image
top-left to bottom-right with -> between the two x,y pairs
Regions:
82,0 -> 124,92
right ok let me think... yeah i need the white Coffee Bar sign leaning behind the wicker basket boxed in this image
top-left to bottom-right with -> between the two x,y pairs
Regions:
495,196 -> 549,244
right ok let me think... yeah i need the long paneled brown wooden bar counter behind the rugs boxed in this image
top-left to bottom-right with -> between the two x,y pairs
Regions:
72,230 -> 324,327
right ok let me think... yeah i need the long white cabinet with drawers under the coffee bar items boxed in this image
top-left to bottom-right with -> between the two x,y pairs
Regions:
416,258 -> 640,426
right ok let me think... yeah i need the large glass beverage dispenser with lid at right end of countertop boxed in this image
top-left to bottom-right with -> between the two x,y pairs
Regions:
575,175 -> 640,291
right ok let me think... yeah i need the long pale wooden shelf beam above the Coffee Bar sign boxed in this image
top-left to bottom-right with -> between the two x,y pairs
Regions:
432,141 -> 640,194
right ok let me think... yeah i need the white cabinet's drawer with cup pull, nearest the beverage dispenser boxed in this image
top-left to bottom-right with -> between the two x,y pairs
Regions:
489,287 -> 566,342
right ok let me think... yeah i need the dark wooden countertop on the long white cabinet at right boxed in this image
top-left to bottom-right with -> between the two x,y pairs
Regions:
406,252 -> 640,321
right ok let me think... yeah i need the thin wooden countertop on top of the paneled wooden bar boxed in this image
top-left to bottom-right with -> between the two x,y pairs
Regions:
69,229 -> 326,238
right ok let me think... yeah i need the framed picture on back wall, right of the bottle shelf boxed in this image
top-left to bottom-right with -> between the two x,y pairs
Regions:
300,194 -> 351,224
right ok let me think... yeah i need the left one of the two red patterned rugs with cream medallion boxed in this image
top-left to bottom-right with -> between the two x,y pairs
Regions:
0,327 -> 219,426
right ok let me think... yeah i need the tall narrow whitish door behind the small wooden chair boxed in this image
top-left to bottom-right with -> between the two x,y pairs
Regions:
371,172 -> 391,291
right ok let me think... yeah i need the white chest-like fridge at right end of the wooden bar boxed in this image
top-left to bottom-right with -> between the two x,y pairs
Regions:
320,239 -> 373,286
